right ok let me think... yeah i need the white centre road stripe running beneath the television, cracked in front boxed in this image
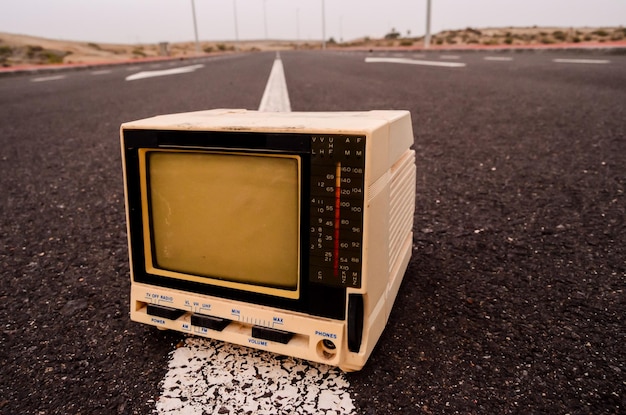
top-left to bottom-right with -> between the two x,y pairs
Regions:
156,54 -> 355,415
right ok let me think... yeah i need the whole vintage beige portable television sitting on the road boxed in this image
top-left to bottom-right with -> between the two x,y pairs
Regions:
121,110 -> 415,371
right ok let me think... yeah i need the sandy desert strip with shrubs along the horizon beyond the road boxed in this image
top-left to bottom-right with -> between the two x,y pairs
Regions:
0,27 -> 626,67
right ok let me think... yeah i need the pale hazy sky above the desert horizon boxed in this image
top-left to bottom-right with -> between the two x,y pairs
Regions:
0,0 -> 626,44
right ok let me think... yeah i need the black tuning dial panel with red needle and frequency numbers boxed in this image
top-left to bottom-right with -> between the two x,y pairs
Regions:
309,135 -> 365,288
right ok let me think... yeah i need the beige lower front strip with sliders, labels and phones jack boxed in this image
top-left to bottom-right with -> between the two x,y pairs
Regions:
131,284 -> 346,365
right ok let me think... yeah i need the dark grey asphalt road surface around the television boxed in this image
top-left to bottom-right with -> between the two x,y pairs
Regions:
0,52 -> 626,414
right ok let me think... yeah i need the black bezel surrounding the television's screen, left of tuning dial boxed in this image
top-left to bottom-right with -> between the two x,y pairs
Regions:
123,129 -> 347,320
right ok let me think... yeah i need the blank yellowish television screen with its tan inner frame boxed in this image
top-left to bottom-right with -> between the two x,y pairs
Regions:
140,149 -> 300,298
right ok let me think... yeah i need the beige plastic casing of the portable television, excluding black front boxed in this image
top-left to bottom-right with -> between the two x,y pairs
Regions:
121,109 -> 416,371
